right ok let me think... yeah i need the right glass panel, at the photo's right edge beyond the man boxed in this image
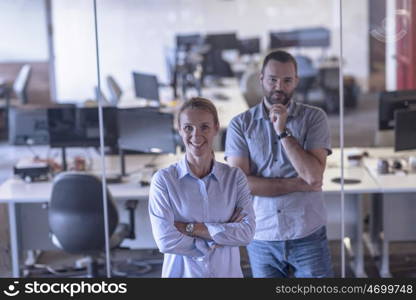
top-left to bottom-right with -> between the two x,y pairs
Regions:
343,0 -> 416,277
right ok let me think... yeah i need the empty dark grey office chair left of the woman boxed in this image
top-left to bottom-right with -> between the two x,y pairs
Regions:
48,172 -> 154,277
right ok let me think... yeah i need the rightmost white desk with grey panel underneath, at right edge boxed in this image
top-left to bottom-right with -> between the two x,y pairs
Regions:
364,148 -> 416,277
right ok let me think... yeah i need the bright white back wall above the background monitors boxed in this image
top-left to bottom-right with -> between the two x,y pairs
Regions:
53,0 -> 368,100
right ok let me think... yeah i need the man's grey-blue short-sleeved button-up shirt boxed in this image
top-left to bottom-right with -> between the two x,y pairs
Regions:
225,101 -> 331,241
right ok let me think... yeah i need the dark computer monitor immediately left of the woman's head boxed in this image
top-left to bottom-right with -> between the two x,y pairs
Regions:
118,108 -> 176,153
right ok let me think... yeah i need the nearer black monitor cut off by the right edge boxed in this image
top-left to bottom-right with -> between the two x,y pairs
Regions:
394,110 -> 416,151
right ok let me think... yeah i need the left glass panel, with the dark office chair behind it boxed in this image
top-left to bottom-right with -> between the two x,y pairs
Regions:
0,0 -> 110,277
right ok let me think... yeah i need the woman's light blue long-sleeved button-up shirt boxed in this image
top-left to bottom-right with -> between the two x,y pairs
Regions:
149,158 -> 255,277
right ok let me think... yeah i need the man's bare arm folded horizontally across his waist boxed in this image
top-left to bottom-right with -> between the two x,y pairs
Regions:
227,156 -> 322,197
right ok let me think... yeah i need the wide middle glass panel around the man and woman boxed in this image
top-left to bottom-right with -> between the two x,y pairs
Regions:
97,0 -> 342,277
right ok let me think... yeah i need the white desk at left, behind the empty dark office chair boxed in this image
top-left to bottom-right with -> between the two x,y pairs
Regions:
0,154 -> 179,277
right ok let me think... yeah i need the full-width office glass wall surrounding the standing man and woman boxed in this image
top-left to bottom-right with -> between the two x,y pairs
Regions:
0,0 -> 416,277
